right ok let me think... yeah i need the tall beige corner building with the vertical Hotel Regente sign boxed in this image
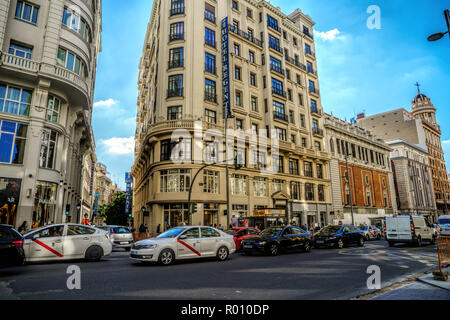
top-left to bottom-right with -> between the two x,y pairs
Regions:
132,0 -> 331,232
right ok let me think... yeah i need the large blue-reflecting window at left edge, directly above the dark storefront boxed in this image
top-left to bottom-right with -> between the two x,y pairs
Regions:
0,120 -> 28,164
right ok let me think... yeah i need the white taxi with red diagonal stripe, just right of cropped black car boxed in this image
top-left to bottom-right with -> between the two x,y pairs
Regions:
23,224 -> 112,262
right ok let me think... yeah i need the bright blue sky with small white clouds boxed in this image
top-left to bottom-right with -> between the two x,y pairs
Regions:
92,0 -> 450,189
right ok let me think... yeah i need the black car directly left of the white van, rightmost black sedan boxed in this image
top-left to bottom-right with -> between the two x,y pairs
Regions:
314,225 -> 365,249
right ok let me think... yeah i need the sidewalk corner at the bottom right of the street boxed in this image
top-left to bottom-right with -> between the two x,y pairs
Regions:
370,268 -> 450,300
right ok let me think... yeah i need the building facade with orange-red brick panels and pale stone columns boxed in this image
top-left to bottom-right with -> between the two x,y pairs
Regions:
324,114 -> 397,225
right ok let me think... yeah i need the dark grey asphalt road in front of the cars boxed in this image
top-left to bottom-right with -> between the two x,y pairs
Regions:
0,240 -> 437,300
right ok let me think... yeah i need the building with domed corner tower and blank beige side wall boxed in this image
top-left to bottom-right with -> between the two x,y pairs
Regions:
357,91 -> 450,214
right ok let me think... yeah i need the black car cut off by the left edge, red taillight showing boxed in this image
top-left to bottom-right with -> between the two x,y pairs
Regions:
0,224 -> 25,267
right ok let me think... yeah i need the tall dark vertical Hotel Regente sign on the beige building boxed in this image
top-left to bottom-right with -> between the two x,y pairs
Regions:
222,17 -> 231,118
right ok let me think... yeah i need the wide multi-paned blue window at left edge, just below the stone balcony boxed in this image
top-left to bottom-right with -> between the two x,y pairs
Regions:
0,84 -> 32,116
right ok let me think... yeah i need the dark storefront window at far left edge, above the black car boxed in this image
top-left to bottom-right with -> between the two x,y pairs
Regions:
0,178 -> 22,226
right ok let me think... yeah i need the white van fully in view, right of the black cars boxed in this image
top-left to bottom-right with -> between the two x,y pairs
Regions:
385,215 -> 435,247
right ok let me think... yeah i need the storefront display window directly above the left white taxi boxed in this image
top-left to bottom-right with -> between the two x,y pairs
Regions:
32,181 -> 58,228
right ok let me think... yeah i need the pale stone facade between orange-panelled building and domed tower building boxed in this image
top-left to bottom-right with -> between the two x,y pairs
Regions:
387,140 -> 437,221
